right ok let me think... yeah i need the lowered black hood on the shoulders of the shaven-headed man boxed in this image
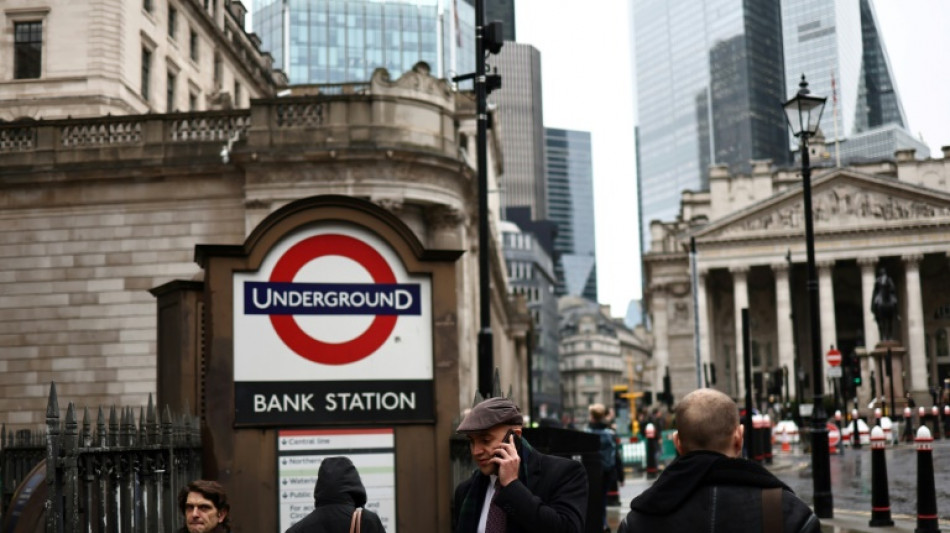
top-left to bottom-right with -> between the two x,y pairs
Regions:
630,451 -> 791,515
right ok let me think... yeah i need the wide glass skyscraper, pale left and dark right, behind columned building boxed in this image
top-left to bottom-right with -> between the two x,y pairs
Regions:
633,0 -> 789,247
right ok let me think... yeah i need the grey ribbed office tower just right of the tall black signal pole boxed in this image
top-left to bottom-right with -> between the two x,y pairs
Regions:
488,42 -> 547,220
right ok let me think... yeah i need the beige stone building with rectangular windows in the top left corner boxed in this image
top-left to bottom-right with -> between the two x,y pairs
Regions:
0,0 -> 287,121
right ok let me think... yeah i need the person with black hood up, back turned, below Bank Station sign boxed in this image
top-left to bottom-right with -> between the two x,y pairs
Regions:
286,457 -> 386,533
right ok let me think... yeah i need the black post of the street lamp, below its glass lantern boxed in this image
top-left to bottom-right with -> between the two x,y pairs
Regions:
801,131 -> 834,518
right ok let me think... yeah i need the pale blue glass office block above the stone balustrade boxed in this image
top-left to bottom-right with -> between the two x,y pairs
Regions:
253,0 -> 475,84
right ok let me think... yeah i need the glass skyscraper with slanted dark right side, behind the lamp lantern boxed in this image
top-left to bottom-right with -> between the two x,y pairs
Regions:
782,0 -> 930,164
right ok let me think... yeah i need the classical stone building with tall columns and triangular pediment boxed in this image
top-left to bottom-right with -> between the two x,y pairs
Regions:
644,142 -> 950,408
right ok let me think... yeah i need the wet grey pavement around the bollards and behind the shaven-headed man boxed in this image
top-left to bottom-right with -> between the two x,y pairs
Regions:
607,440 -> 950,533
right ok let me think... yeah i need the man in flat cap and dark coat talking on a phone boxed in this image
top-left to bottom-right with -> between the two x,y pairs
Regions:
452,397 -> 587,533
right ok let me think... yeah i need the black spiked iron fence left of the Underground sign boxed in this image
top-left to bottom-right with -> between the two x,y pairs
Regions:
0,384 -> 201,533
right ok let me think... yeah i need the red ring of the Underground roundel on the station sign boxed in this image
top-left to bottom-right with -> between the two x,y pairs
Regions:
270,234 -> 397,365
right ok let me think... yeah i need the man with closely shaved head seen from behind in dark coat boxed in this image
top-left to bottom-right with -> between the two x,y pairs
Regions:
618,389 -> 821,533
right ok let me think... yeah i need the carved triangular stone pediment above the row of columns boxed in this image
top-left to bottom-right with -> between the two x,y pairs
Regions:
694,169 -> 950,241
